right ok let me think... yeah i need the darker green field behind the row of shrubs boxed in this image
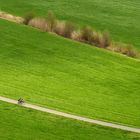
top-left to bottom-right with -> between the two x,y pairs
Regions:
0,0 -> 140,50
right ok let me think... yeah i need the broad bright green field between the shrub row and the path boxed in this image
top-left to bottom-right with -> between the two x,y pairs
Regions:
0,20 -> 140,126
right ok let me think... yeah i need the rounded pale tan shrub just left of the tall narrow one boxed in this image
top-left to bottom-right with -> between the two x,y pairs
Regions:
28,18 -> 48,31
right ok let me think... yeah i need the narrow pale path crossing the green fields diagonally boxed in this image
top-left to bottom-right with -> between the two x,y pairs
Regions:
0,96 -> 140,133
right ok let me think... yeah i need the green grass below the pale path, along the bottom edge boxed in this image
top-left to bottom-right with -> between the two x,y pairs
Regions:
0,102 -> 140,140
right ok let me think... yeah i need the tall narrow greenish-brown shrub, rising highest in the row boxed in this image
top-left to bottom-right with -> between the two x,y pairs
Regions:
46,11 -> 57,32
